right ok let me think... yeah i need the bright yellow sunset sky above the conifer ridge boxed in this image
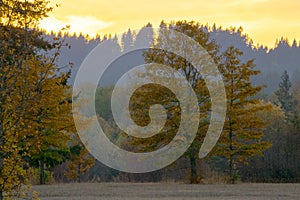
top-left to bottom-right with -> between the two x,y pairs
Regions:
41,0 -> 300,47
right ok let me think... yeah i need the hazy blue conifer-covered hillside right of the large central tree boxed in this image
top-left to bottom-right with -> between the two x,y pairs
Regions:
209,25 -> 300,94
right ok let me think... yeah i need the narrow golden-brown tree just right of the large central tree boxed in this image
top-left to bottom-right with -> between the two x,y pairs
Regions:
214,47 -> 270,183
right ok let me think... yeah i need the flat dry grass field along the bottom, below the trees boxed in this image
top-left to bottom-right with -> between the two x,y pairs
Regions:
33,183 -> 300,200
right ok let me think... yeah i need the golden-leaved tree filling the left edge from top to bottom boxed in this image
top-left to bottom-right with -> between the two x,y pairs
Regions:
0,0 -> 73,199
